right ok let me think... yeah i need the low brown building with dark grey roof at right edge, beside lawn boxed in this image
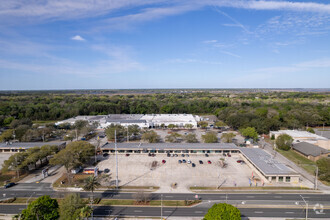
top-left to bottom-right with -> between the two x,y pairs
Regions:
292,142 -> 330,162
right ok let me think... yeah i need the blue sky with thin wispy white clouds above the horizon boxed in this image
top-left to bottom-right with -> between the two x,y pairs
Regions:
0,0 -> 330,90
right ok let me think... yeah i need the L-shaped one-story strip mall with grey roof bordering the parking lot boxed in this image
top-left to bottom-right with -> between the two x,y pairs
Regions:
101,143 -> 300,183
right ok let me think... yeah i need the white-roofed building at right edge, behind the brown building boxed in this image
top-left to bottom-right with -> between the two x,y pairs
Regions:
269,130 -> 330,150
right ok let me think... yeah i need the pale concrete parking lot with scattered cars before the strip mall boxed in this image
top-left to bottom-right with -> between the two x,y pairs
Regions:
98,154 -> 252,192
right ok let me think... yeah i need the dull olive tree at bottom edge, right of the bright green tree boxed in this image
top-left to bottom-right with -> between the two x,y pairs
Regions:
59,193 -> 91,220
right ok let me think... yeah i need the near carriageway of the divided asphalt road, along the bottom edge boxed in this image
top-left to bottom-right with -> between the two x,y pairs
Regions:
0,205 -> 330,219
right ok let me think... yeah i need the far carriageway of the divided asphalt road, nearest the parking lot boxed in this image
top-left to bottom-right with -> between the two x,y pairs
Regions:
0,183 -> 330,205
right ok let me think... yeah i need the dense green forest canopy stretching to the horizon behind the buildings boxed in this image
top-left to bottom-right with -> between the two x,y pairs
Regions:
0,90 -> 330,133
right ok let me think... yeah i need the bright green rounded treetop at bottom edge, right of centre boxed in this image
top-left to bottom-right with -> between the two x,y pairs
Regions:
204,203 -> 241,220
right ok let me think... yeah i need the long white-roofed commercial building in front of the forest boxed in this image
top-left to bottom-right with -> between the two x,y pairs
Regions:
55,114 -> 201,129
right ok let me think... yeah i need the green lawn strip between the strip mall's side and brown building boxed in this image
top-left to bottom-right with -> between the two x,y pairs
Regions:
276,149 -> 316,175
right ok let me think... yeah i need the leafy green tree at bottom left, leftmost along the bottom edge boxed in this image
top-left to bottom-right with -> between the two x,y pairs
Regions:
21,195 -> 59,220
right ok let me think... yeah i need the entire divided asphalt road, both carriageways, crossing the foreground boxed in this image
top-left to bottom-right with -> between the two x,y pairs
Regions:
0,183 -> 330,219
